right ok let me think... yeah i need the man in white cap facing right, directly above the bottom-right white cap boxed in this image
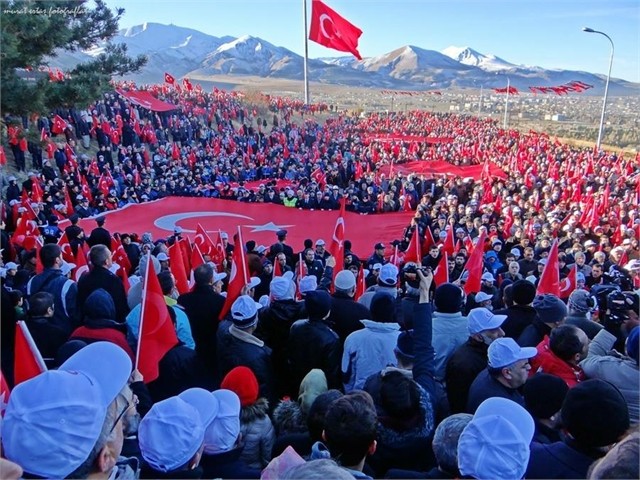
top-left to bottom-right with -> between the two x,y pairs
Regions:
467,338 -> 538,413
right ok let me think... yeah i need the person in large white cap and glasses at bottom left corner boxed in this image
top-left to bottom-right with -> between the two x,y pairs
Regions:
2,342 -> 131,478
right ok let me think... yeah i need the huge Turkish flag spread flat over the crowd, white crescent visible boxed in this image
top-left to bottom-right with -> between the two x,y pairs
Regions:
65,197 -> 414,258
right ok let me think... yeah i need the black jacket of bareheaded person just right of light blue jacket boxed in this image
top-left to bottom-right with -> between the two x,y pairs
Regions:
178,285 -> 224,378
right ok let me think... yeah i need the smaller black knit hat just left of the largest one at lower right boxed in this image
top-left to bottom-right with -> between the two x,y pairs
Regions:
524,373 -> 569,418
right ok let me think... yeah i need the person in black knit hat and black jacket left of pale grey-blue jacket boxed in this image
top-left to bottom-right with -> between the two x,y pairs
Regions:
288,290 -> 342,390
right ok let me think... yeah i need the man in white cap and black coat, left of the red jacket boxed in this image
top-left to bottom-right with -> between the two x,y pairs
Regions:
445,308 -> 506,413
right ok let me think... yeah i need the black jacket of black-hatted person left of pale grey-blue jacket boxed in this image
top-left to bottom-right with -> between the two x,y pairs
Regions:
288,320 -> 342,391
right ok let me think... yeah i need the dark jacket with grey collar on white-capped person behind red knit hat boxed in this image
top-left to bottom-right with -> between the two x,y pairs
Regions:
217,322 -> 276,405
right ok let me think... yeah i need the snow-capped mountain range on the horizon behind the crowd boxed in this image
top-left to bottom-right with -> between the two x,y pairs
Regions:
49,23 -> 640,95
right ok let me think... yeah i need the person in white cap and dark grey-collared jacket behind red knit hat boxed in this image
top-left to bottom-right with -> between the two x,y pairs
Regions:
217,295 -> 277,405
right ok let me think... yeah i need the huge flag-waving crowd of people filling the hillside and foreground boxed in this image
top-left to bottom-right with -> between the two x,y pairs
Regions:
0,80 -> 640,479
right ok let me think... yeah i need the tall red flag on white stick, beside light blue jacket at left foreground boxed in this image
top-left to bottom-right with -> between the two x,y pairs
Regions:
136,251 -> 178,383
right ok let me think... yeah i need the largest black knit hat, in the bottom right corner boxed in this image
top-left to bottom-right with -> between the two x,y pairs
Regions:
560,379 -> 629,447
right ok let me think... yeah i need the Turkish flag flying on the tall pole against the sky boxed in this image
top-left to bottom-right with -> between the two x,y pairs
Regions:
309,0 -> 362,60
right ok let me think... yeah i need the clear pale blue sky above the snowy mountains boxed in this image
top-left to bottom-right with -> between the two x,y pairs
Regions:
106,0 -> 640,82
